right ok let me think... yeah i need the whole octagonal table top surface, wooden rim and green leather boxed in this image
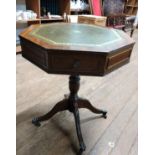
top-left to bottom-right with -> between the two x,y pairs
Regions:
20,23 -> 134,52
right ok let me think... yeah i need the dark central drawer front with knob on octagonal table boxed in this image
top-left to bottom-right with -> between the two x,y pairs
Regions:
49,54 -> 103,74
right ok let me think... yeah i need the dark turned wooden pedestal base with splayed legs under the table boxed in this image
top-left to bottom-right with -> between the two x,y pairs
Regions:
32,75 -> 107,151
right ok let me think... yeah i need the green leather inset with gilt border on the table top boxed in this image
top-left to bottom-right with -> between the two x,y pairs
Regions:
29,23 -> 121,46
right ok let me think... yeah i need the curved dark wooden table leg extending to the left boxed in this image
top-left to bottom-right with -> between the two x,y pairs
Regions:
32,99 -> 68,126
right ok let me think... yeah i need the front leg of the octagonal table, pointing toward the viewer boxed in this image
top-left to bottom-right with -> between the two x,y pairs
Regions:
73,102 -> 86,152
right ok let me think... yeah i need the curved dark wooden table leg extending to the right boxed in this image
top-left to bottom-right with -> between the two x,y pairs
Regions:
78,98 -> 107,118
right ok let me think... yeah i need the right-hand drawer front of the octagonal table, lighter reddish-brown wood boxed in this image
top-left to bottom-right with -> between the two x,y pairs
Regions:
106,48 -> 132,70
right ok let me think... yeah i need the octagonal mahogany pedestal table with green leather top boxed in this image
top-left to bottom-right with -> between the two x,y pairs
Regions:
20,23 -> 134,151
